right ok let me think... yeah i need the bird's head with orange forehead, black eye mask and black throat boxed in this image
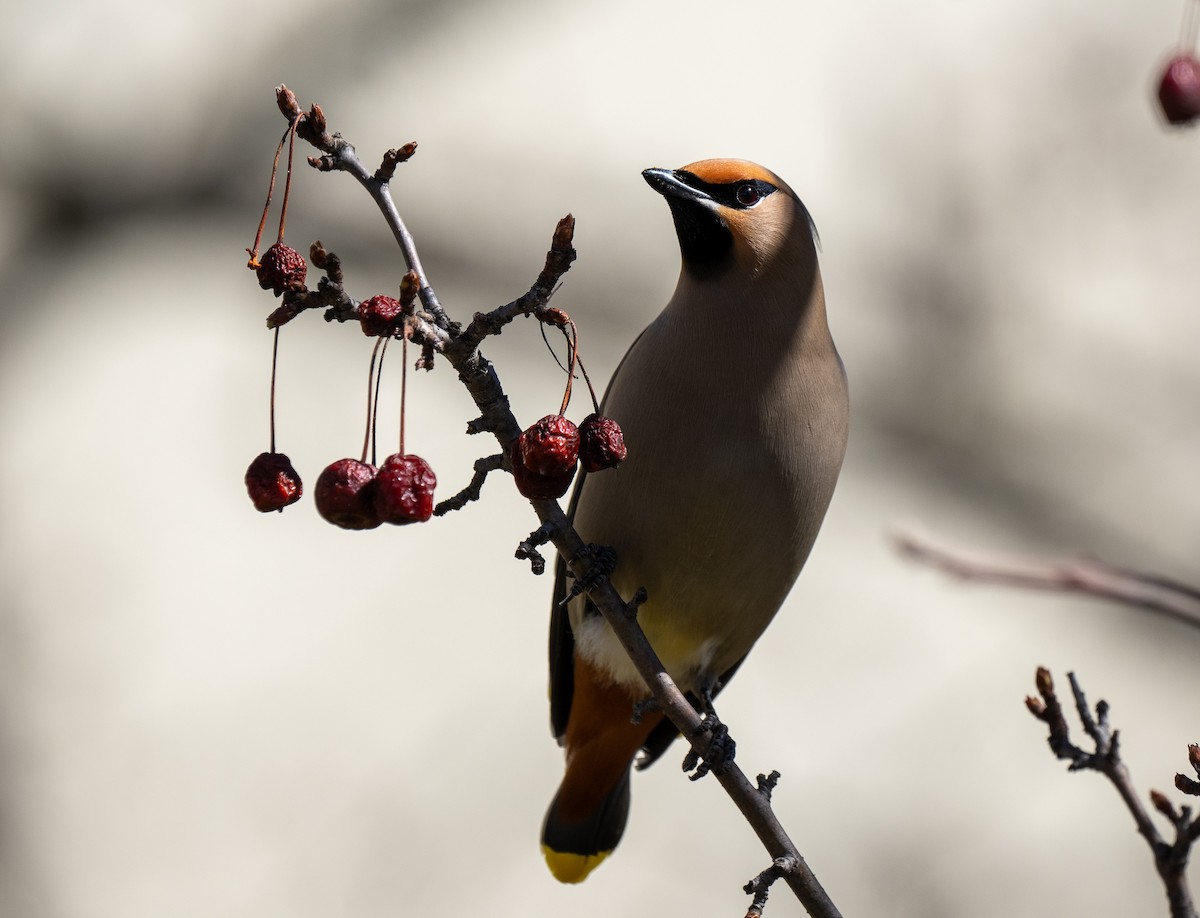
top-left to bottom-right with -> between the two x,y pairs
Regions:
642,160 -> 816,277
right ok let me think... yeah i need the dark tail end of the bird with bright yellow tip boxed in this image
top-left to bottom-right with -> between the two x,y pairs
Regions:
541,767 -> 630,883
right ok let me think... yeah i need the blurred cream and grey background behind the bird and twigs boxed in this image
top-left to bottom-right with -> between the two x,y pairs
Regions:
0,0 -> 1200,918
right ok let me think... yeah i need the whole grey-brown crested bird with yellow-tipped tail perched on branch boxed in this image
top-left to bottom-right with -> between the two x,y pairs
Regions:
542,160 -> 848,882
